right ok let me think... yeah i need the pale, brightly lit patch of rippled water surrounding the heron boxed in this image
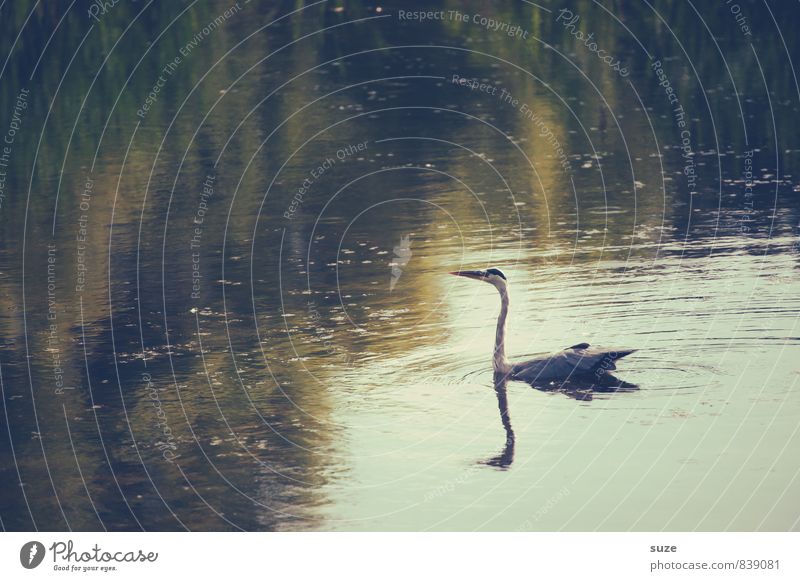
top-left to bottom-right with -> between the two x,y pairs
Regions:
310,233 -> 799,530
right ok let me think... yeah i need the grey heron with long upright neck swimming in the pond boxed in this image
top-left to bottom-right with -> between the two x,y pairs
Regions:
450,268 -> 636,384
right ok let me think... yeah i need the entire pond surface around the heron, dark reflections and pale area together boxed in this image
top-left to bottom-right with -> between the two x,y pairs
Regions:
0,0 -> 800,530
